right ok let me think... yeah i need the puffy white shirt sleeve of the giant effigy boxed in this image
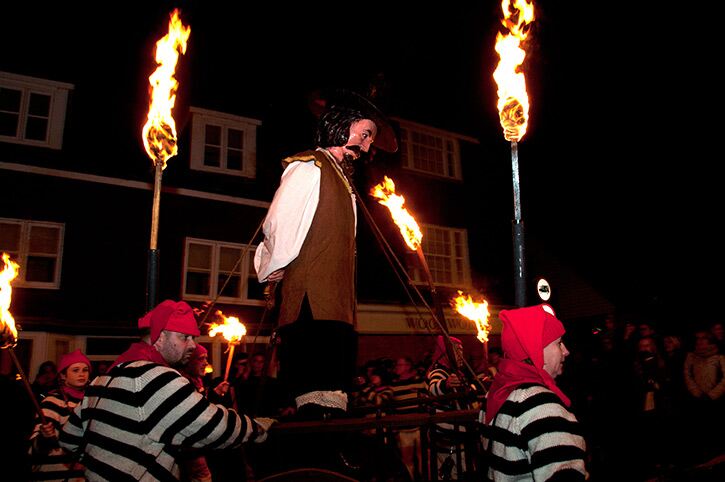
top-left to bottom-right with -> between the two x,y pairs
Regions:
254,161 -> 320,283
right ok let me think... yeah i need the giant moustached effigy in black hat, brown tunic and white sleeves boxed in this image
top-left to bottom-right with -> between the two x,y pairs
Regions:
254,91 -> 397,419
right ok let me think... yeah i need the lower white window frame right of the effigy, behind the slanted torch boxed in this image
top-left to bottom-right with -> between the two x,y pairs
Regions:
409,223 -> 471,288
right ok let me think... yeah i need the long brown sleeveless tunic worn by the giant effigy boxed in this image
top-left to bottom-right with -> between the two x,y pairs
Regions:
279,151 -> 355,325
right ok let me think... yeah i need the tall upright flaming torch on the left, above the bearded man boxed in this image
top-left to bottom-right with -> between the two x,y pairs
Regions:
141,9 -> 191,310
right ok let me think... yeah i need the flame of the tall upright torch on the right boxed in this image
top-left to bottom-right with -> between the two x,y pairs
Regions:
493,0 -> 534,141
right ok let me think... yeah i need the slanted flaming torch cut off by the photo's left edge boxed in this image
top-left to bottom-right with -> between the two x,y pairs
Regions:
0,253 -> 45,423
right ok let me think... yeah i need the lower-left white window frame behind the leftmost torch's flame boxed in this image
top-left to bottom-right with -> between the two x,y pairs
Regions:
0,218 -> 65,290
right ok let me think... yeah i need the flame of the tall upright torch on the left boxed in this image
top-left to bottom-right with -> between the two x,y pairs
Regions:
142,9 -> 191,169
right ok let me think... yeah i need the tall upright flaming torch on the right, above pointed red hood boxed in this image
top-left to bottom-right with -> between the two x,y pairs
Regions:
493,0 -> 534,306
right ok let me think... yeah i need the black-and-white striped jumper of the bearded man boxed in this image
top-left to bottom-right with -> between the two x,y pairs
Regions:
60,360 -> 256,482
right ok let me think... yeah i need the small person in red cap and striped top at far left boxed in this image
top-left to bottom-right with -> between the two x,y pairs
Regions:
30,350 -> 91,482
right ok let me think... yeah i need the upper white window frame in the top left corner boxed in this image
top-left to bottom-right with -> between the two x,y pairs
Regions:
0,72 -> 74,150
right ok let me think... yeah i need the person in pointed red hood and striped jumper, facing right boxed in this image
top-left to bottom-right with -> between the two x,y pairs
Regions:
481,304 -> 587,482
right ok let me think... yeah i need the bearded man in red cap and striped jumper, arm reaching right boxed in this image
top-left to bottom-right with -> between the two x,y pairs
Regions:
59,300 -> 269,481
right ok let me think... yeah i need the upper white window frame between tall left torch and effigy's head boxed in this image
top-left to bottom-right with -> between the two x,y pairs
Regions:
189,107 -> 262,179
